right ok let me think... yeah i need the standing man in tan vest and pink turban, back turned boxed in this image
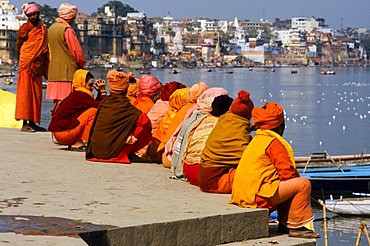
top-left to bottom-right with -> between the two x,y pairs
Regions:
46,3 -> 86,113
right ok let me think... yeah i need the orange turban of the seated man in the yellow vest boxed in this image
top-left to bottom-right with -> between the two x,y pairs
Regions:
252,102 -> 284,130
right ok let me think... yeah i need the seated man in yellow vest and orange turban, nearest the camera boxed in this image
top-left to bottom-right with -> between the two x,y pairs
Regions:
229,102 -> 320,238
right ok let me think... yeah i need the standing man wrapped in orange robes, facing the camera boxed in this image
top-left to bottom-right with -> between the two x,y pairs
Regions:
15,2 -> 49,132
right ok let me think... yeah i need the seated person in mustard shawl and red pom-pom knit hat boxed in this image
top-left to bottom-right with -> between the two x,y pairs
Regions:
197,90 -> 254,193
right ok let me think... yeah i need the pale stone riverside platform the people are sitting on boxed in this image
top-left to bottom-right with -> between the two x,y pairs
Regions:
0,128 -> 316,246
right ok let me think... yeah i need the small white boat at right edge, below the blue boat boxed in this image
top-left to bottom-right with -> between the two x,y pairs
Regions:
325,196 -> 370,216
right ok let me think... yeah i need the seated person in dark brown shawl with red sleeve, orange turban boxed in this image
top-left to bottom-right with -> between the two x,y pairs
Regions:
86,70 -> 152,164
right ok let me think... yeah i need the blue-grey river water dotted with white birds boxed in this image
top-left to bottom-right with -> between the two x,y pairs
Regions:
0,67 -> 370,245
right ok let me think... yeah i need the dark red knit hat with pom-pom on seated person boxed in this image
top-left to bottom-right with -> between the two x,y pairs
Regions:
229,90 -> 254,120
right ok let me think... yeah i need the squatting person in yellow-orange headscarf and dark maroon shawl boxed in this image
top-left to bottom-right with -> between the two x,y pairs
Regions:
48,69 -> 107,151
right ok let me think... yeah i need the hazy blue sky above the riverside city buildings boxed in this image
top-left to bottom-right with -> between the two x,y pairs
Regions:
10,0 -> 370,29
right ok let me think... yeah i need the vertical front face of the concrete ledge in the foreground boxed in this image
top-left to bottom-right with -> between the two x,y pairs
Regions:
79,210 -> 269,246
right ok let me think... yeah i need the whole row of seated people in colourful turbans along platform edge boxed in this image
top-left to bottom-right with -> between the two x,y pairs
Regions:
48,69 -> 320,238
